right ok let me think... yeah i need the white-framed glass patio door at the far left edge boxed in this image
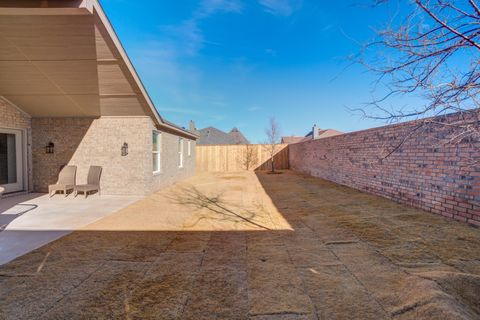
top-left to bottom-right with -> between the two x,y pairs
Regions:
0,128 -> 23,193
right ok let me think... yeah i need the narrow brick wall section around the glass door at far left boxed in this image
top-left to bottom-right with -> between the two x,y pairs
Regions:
0,98 -> 32,190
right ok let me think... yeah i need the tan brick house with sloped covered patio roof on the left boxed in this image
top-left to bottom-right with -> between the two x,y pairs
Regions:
0,0 -> 198,195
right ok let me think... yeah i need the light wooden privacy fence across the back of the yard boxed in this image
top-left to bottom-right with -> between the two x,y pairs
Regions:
196,144 -> 289,172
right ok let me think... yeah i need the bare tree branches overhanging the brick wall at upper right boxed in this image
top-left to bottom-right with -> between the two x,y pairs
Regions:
354,0 -> 480,159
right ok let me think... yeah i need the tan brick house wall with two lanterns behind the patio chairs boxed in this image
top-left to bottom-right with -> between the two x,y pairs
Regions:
32,117 -> 195,195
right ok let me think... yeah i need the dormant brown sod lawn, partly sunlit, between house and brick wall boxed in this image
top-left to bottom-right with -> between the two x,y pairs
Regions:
0,171 -> 480,319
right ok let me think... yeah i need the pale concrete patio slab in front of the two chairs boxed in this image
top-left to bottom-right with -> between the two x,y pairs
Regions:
0,193 -> 141,265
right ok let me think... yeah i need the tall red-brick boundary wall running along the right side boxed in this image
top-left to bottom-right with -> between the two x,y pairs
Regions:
290,114 -> 480,226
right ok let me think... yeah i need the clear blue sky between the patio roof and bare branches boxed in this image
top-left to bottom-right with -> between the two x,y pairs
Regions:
102,0 -> 419,142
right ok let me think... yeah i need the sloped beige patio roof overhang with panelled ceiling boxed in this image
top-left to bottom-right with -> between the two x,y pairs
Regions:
0,0 -> 197,138
